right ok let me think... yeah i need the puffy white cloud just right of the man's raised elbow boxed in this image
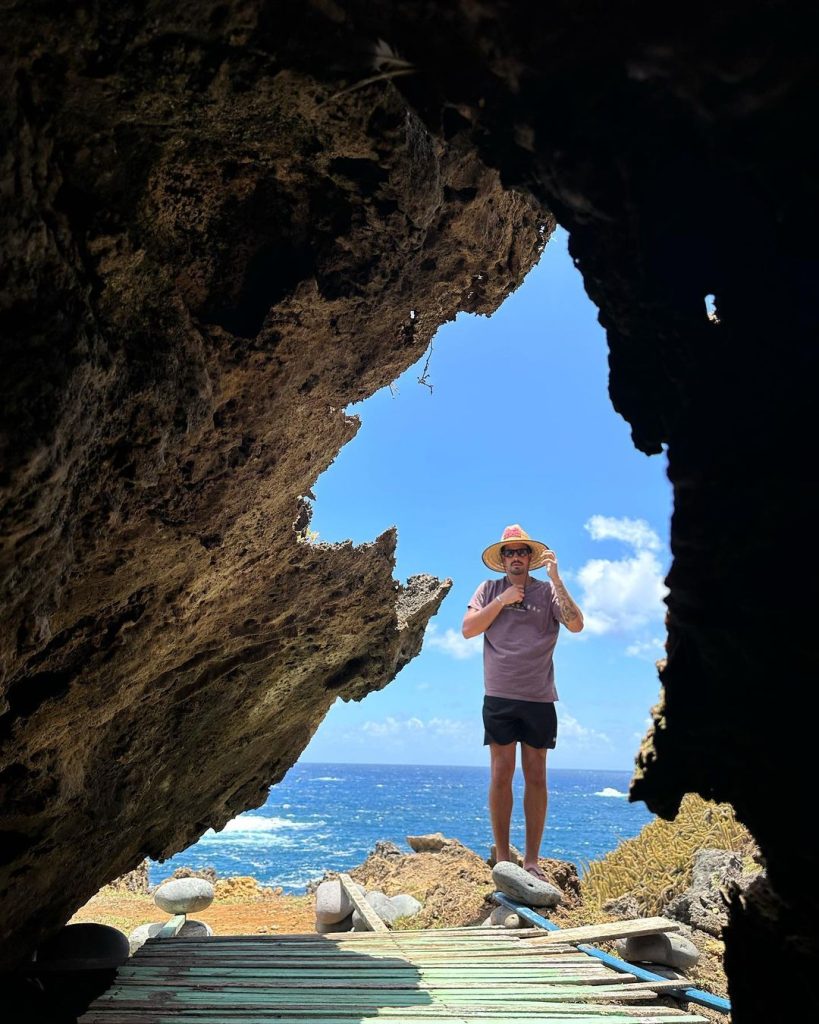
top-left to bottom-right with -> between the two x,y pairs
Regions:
576,515 -> 667,635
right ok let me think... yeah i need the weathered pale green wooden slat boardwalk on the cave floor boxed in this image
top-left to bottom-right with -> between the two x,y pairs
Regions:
80,928 -> 706,1024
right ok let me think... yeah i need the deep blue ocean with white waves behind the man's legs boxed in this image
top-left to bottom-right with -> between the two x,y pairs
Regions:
149,764 -> 653,893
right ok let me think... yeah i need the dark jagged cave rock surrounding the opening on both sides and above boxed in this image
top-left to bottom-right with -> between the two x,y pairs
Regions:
0,0 -> 819,1021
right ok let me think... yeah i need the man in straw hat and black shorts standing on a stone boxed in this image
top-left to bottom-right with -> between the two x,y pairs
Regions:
462,523 -> 584,879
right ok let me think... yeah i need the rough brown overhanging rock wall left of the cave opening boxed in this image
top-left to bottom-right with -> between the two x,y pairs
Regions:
0,3 -> 554,963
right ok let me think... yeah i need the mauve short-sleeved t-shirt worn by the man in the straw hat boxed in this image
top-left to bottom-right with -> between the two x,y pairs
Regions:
469,577 -> 560,703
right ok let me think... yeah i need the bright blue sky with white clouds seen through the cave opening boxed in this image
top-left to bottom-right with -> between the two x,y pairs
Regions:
301,230 -> 672,770
